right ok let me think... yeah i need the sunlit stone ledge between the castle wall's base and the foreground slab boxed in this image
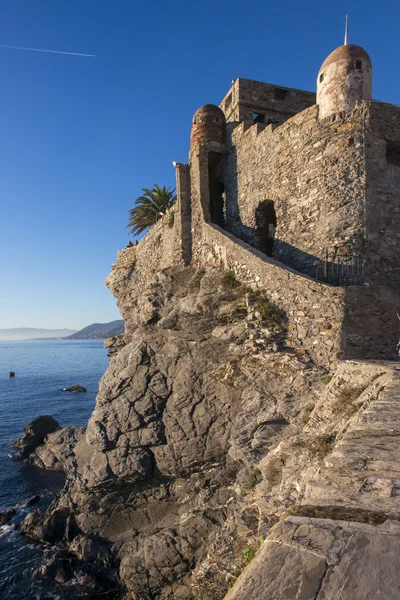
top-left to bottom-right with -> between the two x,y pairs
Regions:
303,364 -> 400,515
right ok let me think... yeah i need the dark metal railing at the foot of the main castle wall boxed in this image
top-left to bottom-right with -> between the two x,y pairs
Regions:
316,250 -> 365,285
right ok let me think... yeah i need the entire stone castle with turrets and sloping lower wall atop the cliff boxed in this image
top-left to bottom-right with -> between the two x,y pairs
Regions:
114,36 -> 400,367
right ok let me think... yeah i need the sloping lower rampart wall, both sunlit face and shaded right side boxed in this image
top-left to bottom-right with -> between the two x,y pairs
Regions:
196,223 -> 398,369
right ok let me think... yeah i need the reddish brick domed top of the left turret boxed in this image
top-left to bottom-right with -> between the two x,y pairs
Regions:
190,104 -> 226,148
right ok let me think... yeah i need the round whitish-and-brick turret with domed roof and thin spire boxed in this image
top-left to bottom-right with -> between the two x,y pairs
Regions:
317,16 -> 372,119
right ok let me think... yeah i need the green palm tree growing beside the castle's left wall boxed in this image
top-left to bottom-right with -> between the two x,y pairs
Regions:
127,184 -> 176,235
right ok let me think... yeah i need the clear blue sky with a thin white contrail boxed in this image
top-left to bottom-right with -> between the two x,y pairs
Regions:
0,0 -> 400,328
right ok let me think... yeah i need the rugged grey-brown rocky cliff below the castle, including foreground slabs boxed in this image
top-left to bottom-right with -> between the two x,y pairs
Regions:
16,267 -> 400,600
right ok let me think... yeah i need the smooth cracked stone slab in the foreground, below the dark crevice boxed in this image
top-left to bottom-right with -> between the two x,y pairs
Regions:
225,517 -> 400,600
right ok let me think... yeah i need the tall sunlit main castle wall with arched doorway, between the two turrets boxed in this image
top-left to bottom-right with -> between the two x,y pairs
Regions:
225,105 -> 366,276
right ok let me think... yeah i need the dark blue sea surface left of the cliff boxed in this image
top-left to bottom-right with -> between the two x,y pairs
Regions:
0,340 -> 108,600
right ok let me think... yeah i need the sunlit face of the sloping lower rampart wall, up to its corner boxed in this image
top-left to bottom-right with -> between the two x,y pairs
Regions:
196,223 -> 344,368
